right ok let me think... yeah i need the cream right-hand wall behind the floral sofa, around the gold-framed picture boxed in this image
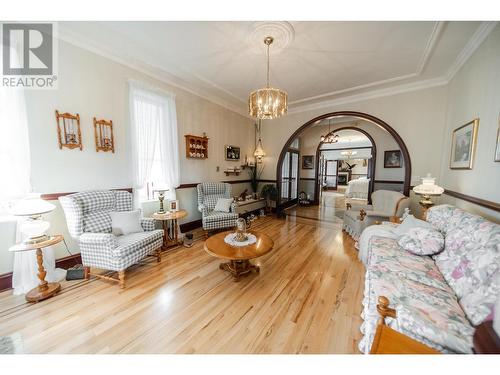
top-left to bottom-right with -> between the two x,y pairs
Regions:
440,26 -> 500,221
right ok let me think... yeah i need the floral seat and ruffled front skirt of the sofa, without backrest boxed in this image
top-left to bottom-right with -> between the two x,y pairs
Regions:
360,237 -> 473,353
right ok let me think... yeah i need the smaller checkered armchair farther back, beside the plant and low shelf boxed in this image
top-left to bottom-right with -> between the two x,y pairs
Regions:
197,182 -> 238,231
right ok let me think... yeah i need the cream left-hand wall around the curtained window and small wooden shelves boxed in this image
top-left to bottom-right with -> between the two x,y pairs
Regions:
0,41 -> 255,274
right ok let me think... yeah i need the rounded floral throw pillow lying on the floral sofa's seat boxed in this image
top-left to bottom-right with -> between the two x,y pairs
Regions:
398,227 -> 444,255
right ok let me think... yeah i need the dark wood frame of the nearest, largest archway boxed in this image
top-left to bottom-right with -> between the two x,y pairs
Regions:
276,111 -> 411,211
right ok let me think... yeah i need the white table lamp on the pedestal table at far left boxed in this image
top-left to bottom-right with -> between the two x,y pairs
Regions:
12,196 -> 56,244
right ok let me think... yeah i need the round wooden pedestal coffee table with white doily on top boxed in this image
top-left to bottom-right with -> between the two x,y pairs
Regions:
204,231 -> 274,281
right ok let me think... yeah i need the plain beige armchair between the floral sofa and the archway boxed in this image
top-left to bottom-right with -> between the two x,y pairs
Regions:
343,190 -> 410,241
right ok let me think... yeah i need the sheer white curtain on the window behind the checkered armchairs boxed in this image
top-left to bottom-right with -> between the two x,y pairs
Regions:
129,81 -> 180,204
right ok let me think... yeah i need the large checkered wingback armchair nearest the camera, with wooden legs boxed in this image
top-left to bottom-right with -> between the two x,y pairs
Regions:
59,190 -> 163,288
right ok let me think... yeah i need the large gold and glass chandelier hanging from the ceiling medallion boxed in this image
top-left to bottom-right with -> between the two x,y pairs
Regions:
248,36 -> 288,120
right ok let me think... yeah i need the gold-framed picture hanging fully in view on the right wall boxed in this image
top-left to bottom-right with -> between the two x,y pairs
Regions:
450,119 -> 479,169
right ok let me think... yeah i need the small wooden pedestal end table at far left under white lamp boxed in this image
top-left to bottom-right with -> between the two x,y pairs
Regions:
9,234 -> 63,302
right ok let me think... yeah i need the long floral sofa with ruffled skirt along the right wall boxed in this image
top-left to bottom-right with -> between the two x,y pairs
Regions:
359,205 -> 500,353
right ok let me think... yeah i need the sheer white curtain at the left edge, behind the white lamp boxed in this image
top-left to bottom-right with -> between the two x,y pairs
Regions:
0,46 -> 66,294
